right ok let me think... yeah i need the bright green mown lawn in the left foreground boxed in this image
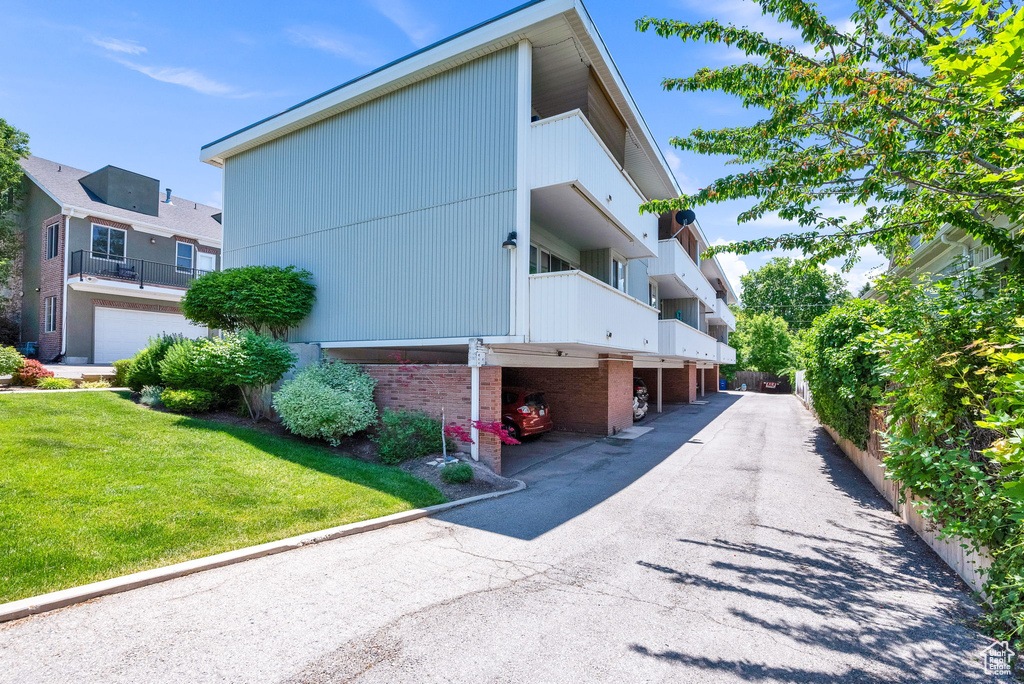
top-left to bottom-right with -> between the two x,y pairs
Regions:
0,392 -> 444,603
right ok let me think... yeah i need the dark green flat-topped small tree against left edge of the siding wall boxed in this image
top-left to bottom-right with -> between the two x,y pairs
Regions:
181,266 -> 316,338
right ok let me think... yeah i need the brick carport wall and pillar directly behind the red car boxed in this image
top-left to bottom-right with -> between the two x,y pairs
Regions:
504,358 -> 633,435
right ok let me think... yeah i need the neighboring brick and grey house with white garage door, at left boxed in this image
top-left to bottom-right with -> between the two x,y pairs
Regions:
10,157 -> 221,364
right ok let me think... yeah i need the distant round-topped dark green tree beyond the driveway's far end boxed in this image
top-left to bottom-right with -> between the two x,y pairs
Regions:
739,257 -> 850,331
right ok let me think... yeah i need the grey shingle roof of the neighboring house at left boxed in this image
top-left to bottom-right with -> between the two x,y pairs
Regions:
22,156 -> 222,242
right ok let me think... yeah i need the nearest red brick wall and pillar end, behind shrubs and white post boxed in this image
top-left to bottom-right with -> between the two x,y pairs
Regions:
362,364 -> 502,474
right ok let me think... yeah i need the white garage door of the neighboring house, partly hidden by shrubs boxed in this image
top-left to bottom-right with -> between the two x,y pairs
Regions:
92,307 -> 207,364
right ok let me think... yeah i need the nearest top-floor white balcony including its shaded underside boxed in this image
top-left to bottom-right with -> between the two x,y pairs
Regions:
529,110 -> 657,259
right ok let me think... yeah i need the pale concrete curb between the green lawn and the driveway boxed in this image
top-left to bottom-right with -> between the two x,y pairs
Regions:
0,479 -> 526,623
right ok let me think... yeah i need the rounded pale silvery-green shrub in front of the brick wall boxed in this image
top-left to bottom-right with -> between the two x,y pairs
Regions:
273,361 -> 377,446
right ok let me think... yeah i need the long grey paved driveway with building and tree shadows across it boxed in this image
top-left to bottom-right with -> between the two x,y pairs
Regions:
0,394 -> 987,682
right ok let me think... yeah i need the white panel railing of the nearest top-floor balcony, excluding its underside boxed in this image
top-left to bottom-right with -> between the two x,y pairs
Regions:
529,110 -> 657,258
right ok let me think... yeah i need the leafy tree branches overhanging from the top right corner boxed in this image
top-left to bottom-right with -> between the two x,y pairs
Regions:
637,0 -> 1024,266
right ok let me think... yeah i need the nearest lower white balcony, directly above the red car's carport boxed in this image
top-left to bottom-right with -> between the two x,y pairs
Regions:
529,270 -> 657,352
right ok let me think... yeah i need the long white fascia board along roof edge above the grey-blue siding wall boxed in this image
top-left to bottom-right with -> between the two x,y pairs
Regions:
200,0 -> 577,167
